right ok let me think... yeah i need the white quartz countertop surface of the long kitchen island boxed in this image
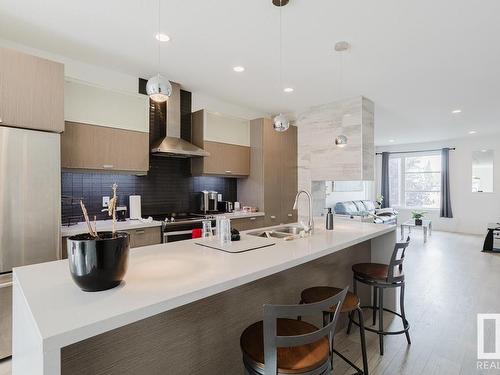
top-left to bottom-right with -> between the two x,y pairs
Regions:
14,220 -> 395,350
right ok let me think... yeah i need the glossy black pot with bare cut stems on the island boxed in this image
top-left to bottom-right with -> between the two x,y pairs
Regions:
68,184 -> 130,292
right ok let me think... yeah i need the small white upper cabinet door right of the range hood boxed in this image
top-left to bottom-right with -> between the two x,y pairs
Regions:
203,111 -> 250,147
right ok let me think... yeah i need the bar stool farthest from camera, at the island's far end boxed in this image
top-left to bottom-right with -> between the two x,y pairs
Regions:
352,237 -> 411,355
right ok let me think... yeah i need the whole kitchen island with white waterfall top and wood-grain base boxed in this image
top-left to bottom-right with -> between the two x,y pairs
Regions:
13,220 -> 396,375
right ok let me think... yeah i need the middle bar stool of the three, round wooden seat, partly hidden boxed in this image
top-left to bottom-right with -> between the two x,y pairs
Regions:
300,286 -> 368,375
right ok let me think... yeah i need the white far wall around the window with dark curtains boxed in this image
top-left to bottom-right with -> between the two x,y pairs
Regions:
376,135 -> 500,234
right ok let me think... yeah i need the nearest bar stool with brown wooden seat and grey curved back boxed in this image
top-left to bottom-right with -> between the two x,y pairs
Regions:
240,288 -> 347,375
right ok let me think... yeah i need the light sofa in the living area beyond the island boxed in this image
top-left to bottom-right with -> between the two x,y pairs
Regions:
334,200 -> 398,224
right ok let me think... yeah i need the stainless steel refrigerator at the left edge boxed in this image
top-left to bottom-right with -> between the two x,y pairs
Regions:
0,126 -> 61,358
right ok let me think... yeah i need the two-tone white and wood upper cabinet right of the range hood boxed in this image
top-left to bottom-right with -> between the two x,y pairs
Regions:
191,110 -> 250,177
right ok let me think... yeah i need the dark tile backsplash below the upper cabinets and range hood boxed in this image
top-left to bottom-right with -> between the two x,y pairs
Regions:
61,156 -> 237,223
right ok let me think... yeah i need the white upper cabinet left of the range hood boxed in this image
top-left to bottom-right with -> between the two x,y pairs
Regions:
64,79 -> 149,133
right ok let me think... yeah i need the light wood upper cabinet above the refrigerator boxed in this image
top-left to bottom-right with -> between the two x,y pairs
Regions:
0,48 -> 64,133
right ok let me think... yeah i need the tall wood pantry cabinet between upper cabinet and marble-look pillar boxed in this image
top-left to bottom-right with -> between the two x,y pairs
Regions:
238,119 -> 298,225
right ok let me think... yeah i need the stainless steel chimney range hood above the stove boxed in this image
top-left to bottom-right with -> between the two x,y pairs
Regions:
151,82 -> 210,158
